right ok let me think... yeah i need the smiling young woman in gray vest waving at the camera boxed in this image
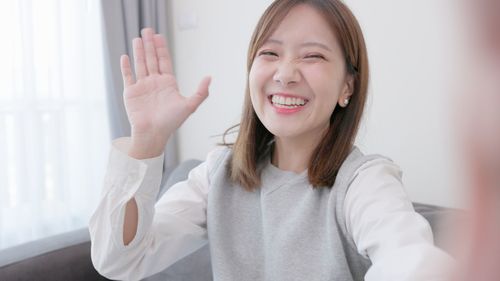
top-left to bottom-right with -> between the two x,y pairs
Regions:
90,0 -> 454,281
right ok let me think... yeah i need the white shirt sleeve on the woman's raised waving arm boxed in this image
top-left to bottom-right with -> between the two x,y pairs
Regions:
89,138 -> 222,280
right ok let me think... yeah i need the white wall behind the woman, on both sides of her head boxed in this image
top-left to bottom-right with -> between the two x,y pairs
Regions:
170,0 -> 463,206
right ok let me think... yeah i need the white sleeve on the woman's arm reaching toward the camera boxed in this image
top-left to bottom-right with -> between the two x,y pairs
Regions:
344,159 -> 454,281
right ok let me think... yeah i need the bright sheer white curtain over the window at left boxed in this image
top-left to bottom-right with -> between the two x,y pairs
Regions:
0,0 -> 110,248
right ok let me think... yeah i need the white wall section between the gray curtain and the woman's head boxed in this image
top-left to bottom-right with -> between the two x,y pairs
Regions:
169,0 -> 270,160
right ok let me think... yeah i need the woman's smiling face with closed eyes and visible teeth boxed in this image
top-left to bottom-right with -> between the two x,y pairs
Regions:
249,4 -> 352,140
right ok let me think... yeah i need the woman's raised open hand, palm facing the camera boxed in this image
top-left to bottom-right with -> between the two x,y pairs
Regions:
120,28 -> 210,159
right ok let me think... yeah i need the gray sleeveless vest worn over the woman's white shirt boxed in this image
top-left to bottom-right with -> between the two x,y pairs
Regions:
207,148 -> 380,281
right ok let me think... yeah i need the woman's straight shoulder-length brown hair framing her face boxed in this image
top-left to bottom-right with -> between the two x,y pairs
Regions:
224,0 -> 369,191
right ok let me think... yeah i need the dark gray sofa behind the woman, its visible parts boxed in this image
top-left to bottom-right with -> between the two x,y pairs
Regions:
0,160 -> 458,281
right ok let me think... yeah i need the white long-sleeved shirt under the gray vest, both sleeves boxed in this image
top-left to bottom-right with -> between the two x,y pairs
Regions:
89,138 -> 453,281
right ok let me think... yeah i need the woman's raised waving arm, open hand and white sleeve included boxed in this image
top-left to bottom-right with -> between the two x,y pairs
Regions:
89,25 -> 210,280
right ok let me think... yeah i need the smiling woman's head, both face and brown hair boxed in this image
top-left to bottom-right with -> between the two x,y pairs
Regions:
240,2 -> 368,185
